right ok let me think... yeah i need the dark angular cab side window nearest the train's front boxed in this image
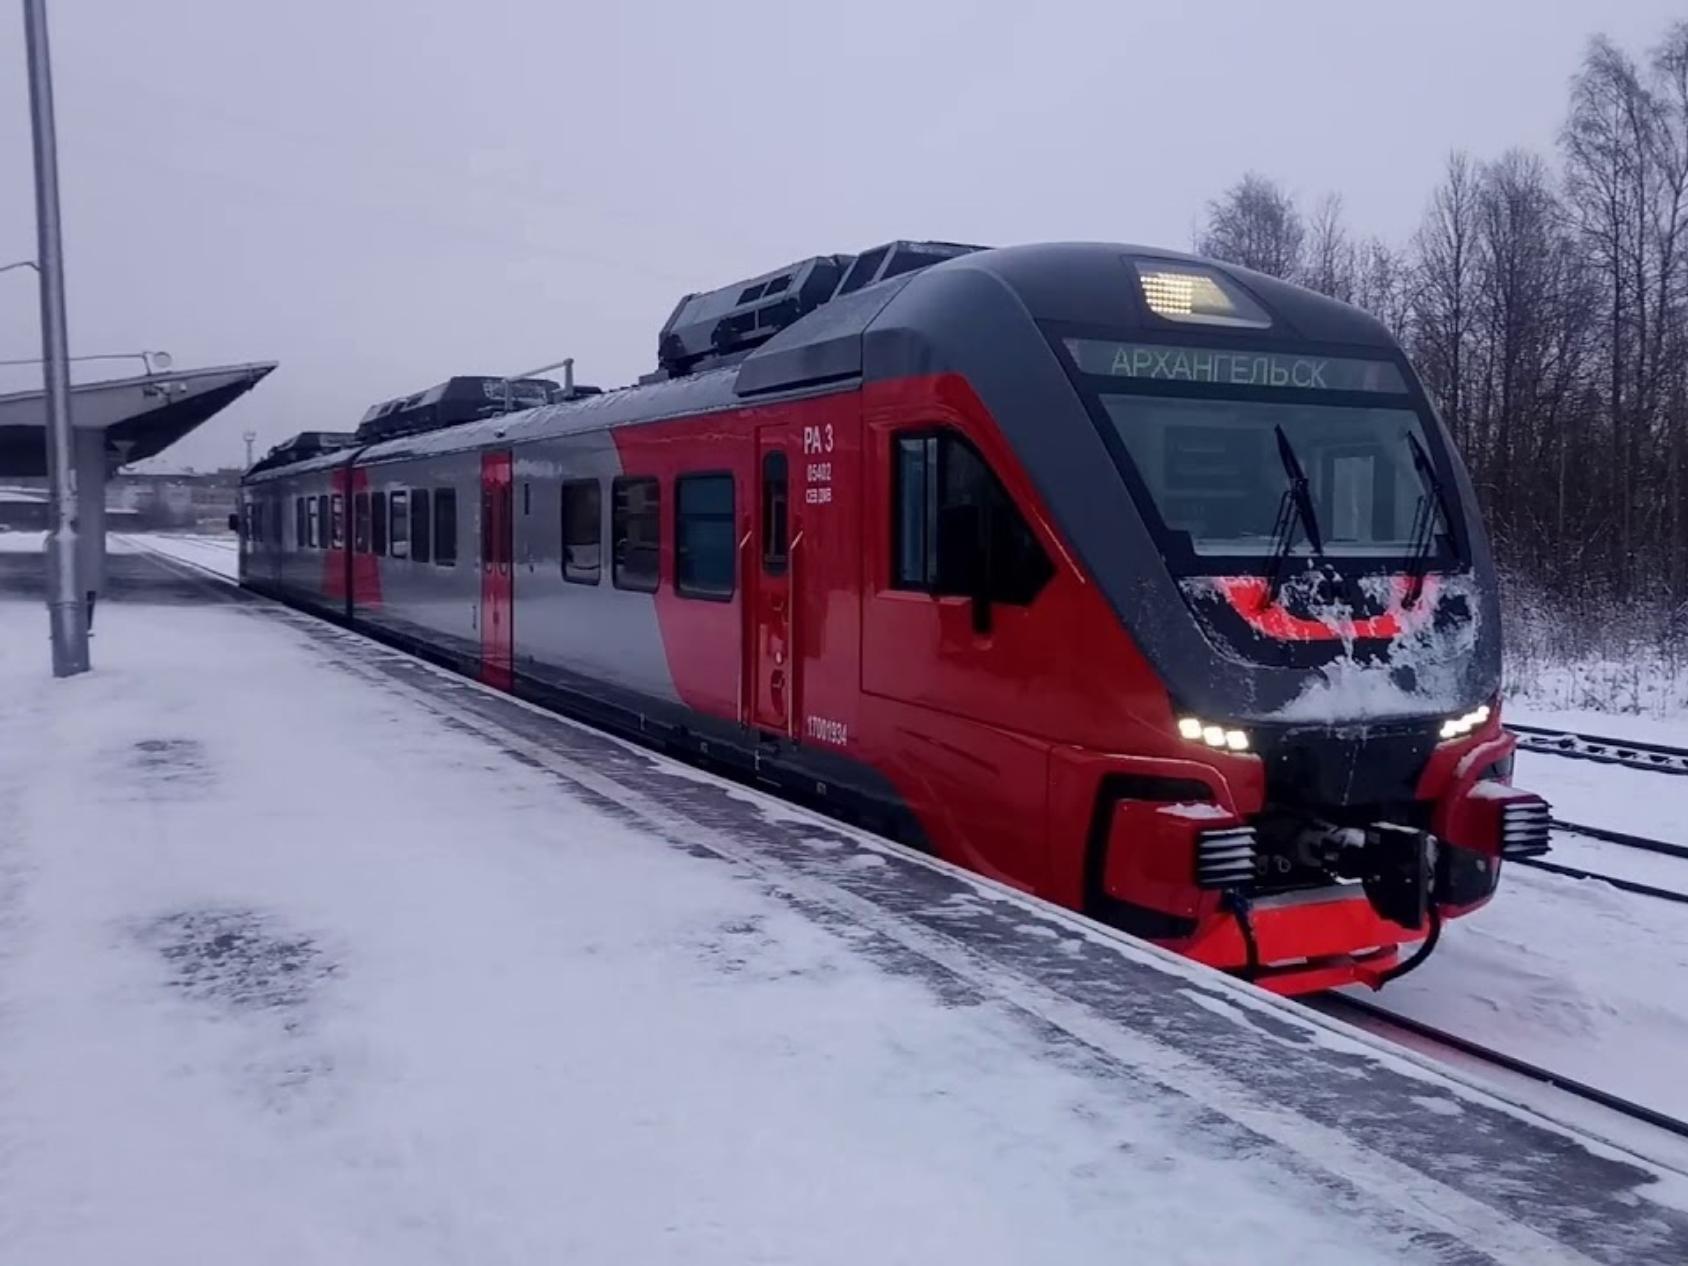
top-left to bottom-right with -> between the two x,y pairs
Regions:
891,432 -> 1055,606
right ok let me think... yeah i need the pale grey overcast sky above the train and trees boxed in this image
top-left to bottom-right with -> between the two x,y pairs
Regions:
0,0 -> 1683,469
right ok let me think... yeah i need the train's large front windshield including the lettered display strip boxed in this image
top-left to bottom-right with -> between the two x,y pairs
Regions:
1065,339 -> 1455,572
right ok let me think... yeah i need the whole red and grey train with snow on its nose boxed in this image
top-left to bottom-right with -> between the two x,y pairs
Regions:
241,241 -> 1548,993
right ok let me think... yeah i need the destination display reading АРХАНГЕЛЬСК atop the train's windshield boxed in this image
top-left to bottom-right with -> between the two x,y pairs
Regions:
1065,339 -> 1406,395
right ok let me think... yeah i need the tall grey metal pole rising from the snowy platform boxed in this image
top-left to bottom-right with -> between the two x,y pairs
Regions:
24,0 -> 88,677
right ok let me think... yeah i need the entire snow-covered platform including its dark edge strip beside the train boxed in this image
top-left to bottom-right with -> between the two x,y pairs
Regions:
0,554 -> 1688,1266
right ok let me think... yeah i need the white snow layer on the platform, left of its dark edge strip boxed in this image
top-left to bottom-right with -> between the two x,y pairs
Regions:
13,584 -> 1323,1263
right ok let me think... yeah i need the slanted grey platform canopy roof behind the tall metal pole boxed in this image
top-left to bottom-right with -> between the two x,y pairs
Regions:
0,361 -> 275,476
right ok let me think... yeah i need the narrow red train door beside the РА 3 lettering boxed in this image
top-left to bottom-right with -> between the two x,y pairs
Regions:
744,425 -> 798,738
